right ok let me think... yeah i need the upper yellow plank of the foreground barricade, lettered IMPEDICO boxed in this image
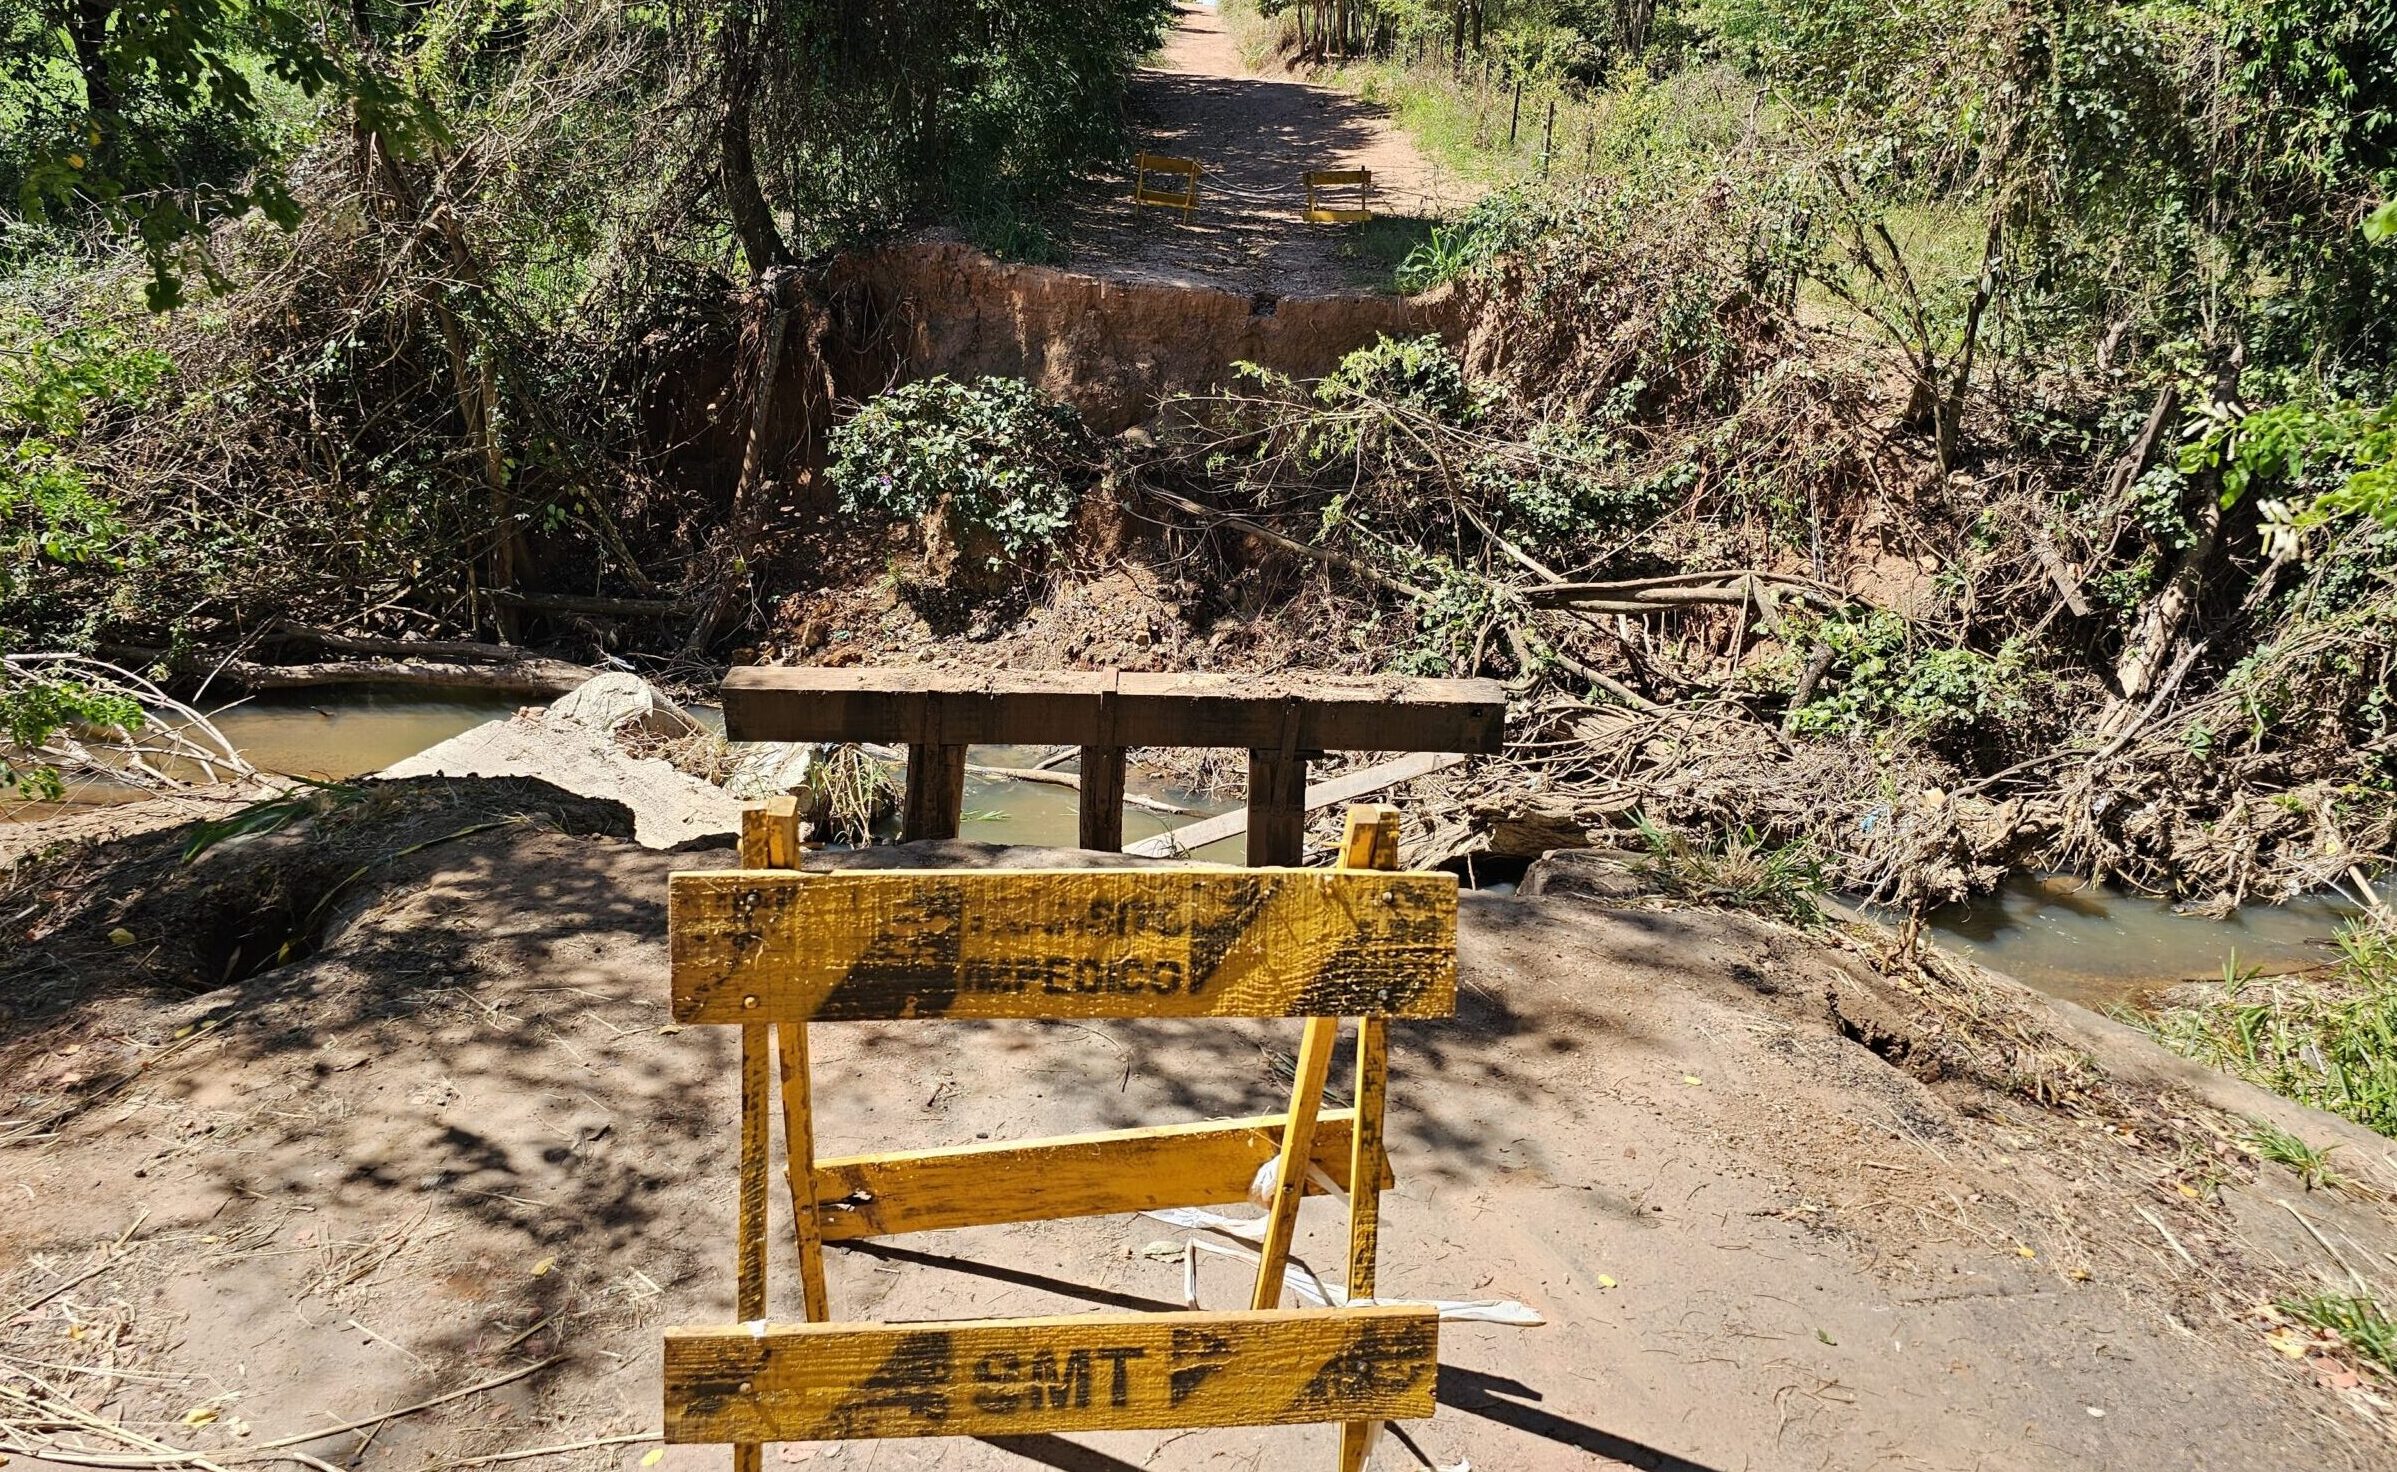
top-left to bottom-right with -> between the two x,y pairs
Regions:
666,868 -> 1457,1024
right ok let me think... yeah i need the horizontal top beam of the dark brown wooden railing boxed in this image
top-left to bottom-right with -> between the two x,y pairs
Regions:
724,666 -> 1505,753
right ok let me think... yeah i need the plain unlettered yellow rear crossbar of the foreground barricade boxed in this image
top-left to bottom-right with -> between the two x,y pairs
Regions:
815,1110 -> 1390,1242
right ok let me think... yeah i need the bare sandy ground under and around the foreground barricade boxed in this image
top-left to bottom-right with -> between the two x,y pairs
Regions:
0,791 -> 2397,1472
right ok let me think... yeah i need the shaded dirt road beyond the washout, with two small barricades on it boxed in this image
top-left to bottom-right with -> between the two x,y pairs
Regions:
1067,5 -> 1472,295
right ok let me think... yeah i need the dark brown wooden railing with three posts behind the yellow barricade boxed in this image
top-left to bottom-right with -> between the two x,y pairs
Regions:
724,666 -> 1505,865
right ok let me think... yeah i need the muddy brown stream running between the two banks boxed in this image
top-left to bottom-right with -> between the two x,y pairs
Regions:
0,686 -> 2356,1009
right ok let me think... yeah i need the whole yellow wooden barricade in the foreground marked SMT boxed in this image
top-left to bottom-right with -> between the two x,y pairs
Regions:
664,798 -> 1457,1472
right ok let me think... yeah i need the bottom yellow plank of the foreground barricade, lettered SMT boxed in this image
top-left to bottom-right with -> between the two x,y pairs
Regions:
664,1307 -> 1441,1443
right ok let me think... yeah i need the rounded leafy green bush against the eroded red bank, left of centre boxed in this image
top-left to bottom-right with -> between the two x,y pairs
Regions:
829,376 -> 1088,568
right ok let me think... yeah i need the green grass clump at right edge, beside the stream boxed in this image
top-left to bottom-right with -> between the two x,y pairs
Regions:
2143,921 -> 2397,1141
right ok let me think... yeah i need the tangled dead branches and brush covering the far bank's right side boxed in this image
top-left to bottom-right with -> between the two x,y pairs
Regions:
1117,170 -> 2397,911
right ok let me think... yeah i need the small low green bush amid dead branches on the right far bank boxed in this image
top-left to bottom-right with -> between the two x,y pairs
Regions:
1791,609 -> 2030,738
